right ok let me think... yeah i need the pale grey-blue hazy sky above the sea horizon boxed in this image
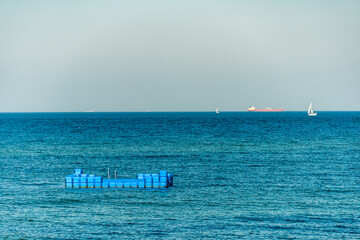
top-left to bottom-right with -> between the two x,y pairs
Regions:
0,0 -> 360,112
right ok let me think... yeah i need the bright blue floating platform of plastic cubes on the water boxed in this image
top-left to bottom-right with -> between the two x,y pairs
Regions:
65,169 -> 173,188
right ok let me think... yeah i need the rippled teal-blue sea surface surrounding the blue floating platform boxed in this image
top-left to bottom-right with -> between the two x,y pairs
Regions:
0,112 -> 360,239
